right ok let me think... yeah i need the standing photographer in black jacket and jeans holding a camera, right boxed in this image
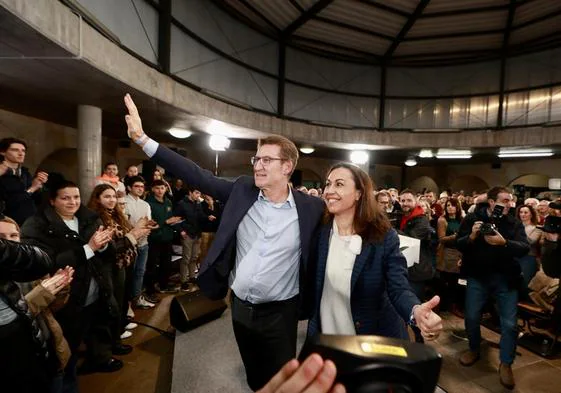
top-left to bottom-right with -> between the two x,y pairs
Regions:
456,187 -> 530,389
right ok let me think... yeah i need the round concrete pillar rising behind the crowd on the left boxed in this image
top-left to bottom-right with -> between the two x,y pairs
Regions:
78,105 -> 102,204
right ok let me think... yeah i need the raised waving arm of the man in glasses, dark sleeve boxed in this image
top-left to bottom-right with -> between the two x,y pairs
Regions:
125,94 -> 234,202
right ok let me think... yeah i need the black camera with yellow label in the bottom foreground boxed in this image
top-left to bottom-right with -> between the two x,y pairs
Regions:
299,334 -> 442,393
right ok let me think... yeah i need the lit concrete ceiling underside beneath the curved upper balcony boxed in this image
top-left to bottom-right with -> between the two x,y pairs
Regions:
0,3 -> 561,165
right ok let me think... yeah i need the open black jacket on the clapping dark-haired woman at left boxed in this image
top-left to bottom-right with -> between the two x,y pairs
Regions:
21,206 -> 116,313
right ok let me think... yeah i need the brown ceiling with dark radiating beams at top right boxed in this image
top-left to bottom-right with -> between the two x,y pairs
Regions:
215,0 -> 561,66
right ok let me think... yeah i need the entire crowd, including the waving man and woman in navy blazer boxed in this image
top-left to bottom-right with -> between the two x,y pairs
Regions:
0,95 -> 561,392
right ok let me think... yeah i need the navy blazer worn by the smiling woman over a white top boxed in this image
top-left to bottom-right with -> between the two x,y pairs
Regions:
308,224 -> 420,339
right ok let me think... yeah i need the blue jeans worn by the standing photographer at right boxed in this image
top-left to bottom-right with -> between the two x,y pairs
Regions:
464,274 -> 518,364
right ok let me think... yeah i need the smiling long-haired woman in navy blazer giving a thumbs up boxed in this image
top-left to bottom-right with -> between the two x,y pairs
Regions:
308,163 -> 442,340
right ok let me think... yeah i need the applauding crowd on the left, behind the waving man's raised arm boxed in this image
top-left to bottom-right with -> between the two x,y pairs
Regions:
0,138 -> 220,392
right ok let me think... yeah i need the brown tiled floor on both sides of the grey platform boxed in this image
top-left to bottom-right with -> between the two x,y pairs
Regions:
80,296 -> 561,393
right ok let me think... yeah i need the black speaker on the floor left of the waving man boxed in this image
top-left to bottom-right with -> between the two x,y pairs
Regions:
169,291 -> 227,332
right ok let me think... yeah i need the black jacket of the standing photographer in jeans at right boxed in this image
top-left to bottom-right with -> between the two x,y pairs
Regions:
456,204 -> 530,287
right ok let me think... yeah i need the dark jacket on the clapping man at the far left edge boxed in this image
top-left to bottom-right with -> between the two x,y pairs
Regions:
0,167 -> 41,226
